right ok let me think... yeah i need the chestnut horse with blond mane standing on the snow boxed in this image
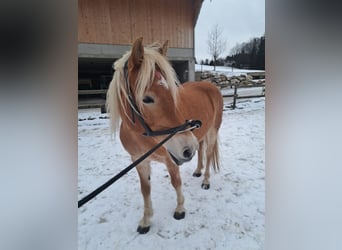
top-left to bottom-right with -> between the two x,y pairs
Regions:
106,37 -> 223,234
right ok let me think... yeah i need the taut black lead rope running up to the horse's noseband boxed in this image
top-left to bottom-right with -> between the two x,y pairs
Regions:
78,120 -> 202,208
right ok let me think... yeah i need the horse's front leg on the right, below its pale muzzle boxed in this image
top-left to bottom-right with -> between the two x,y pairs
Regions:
166,159 -> 185,220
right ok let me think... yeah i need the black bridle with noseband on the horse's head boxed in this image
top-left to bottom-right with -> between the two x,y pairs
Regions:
124,61 -> 202,136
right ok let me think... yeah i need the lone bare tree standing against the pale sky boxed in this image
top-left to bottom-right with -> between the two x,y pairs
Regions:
207,24 -> 226,71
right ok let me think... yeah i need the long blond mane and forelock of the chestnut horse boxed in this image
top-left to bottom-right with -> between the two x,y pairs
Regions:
106,43 -> 180,133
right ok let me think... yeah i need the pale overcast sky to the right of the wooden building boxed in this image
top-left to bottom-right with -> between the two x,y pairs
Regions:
195,0 -> 265,61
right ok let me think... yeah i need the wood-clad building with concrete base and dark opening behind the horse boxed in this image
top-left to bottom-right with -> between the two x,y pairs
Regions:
78,0 -> 203,107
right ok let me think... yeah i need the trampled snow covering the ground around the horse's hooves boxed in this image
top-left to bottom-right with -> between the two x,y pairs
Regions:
78,98 -> 265,250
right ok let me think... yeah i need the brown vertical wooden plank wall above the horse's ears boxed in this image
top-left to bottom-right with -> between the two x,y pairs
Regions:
78,0 -> 202,48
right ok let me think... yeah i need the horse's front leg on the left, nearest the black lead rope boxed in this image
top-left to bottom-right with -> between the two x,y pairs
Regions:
137,161 -> 153,234
